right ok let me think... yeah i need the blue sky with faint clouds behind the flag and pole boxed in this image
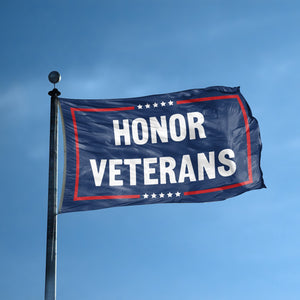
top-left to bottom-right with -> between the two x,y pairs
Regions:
0,0 -> 300,300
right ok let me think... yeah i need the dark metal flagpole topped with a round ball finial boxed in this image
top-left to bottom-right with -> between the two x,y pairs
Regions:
45,71 -> 60,300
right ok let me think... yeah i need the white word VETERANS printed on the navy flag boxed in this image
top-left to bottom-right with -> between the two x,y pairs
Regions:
90,149 -> 236,187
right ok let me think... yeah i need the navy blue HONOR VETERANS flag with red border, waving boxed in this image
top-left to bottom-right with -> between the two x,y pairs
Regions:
59,86 -> 265,213
